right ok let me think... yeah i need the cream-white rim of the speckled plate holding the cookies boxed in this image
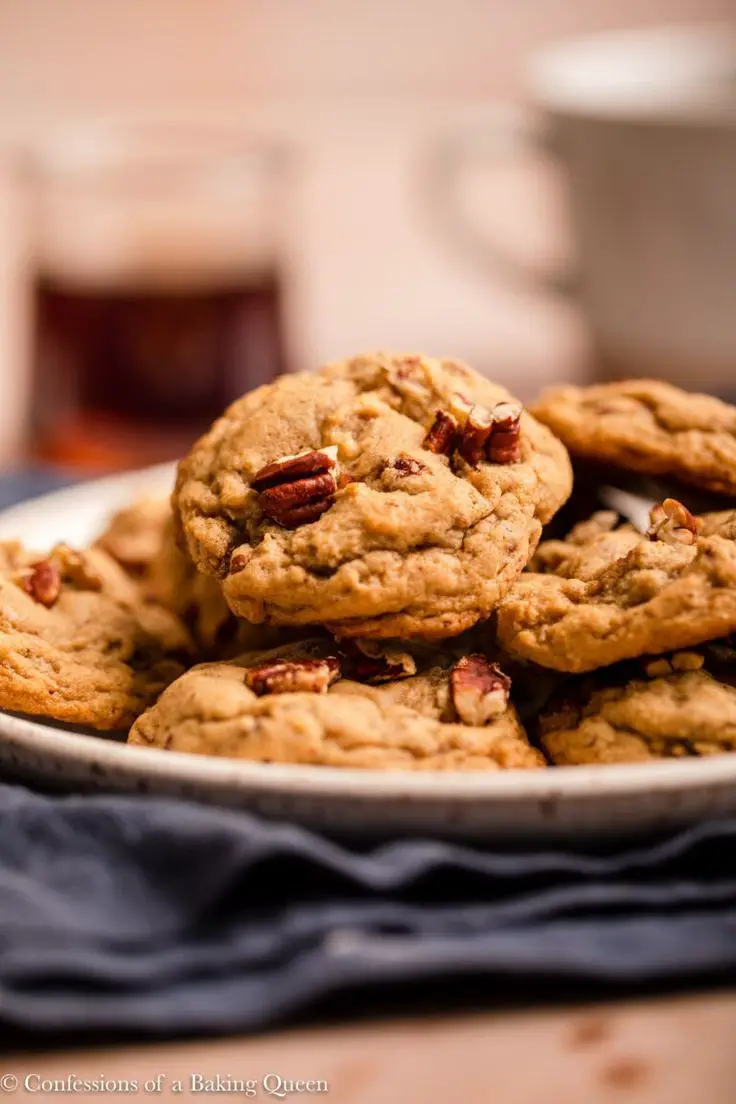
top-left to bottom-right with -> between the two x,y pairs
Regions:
0,465 -> 736,830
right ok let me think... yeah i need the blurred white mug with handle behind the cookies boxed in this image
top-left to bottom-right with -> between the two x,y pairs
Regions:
440,25 -> 736,397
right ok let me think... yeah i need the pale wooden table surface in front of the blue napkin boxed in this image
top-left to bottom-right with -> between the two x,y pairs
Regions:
7,990 -> 736,1104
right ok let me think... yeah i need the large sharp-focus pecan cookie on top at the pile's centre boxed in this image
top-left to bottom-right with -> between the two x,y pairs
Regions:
174,354 -> 572,637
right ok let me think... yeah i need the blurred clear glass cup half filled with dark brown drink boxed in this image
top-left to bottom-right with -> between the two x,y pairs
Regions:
23,123 -> 288,470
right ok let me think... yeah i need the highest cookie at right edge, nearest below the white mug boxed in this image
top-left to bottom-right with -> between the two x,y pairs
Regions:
533,380 -> 736,495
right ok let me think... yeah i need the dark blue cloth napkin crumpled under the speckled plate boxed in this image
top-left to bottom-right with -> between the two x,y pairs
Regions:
0,473 -> 736,1039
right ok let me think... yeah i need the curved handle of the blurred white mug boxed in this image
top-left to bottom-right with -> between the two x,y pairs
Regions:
430,105 -> 579,298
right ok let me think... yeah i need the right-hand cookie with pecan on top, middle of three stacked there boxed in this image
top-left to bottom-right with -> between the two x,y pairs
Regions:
498,499 -> 736,672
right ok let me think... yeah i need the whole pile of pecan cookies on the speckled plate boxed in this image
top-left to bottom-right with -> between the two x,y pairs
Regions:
0,353 -> 736,771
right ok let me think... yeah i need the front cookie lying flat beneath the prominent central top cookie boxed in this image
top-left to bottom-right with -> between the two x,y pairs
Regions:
129,640 -> 544,771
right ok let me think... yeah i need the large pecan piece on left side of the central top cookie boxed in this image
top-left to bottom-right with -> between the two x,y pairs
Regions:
250,446 -> 339,529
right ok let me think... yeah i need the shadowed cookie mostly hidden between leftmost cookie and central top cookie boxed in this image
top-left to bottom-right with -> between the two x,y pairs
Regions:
96,498 -> 291,659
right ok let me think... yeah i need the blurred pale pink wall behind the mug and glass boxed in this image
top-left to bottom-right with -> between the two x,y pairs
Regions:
0,0 -> 734,463
